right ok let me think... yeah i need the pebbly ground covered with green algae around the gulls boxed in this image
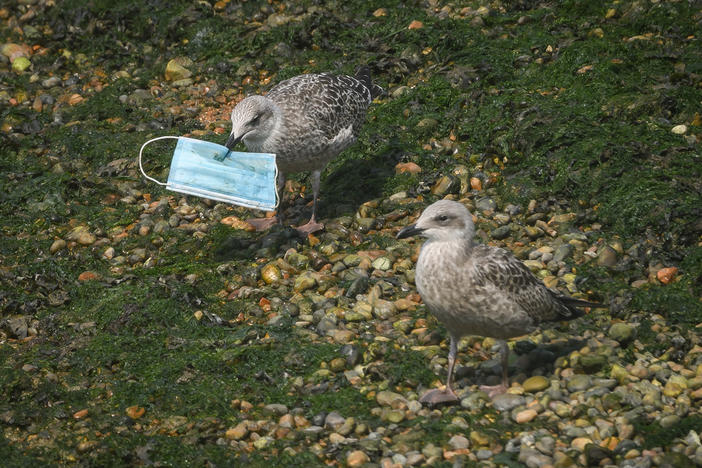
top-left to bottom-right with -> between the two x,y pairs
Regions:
0,0 -> 702,467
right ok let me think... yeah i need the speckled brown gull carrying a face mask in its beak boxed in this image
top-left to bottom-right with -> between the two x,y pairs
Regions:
226,67 -> 383,234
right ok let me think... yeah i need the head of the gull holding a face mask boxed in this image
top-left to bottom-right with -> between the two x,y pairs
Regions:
225,96 -> 277,150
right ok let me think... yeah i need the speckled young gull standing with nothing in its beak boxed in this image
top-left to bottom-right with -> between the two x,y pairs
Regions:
397,200 -> 601,404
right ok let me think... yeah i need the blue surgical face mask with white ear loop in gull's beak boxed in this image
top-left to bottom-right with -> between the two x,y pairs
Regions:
139,136 -> 278,211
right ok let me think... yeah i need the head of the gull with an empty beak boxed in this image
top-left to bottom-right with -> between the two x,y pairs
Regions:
397,200 -> 475,241
